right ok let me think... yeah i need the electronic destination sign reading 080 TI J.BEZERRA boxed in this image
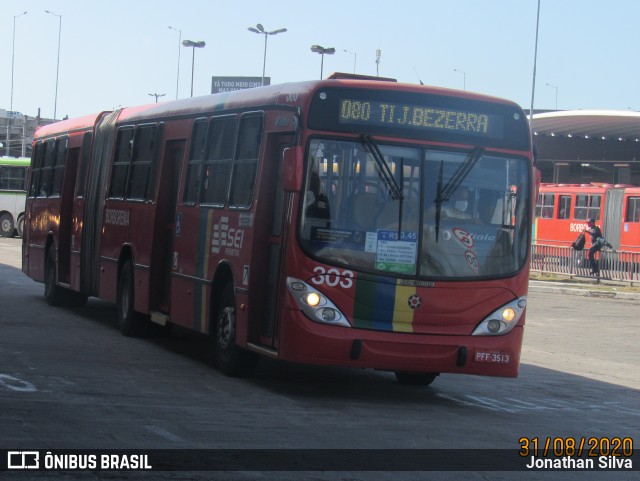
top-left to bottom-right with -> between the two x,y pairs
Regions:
339,98 -> 504,138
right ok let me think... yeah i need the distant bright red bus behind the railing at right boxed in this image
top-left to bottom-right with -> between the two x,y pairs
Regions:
534,184 -> 640,252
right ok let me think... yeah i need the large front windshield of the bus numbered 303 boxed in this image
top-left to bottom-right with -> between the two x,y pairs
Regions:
299,137 -> 531,280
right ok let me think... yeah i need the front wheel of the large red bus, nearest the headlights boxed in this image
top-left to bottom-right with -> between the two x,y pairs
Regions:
215,284 -> 258,377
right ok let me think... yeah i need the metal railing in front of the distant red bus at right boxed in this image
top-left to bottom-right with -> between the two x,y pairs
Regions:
531,244 -> 640,286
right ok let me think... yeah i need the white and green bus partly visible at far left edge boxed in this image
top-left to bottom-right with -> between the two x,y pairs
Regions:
0,157 -> 31,237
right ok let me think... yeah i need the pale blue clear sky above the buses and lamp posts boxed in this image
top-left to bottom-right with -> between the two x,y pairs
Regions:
0,0 -> 640,118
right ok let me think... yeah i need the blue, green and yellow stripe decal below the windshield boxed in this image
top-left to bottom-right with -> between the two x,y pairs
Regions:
353,274 -> 419,332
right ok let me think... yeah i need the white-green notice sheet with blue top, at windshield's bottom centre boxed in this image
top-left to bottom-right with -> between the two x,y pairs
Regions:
376,230 -> 418,274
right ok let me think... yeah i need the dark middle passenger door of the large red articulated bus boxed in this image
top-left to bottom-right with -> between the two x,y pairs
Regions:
150,140 -> 186,313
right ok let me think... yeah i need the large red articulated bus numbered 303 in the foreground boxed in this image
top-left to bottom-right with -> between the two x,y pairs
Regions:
23,75 -> 535,384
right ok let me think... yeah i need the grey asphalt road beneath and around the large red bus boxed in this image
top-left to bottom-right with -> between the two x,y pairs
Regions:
0,239 -> 640,481
